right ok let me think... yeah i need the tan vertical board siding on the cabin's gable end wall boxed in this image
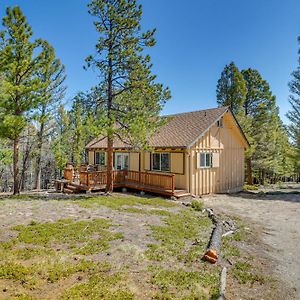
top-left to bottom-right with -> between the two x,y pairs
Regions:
189,113 -> 244,195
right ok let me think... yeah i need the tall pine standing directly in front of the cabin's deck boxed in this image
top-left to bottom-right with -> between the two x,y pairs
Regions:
86,0 -> 170,192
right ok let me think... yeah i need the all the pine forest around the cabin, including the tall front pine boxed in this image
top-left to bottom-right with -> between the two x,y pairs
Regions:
0,0 -> 300,193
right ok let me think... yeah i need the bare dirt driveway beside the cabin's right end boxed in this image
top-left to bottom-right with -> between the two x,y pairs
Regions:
204,185 -> 300,299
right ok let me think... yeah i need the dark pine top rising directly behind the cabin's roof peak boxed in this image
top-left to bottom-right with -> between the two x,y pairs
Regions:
217,62 -> 247,114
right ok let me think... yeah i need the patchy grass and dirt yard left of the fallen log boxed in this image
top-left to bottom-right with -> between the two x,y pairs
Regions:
0,194 -> 219,299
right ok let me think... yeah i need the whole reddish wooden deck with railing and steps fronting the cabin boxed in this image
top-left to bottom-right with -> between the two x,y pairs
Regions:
64,169 -> 190,198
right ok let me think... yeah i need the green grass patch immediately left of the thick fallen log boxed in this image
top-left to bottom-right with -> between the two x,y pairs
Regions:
145,209 -> 211,261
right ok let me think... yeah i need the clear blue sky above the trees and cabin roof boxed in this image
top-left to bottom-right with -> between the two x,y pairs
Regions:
0,0 -> 300,121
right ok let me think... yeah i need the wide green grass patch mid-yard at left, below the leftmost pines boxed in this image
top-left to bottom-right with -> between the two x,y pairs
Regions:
13,219 -> 122,254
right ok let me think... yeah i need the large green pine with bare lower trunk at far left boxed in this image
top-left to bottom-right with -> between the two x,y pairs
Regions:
0,6 -> 51,194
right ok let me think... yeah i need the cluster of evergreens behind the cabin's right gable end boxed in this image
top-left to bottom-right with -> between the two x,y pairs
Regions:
217,63 -> 293,185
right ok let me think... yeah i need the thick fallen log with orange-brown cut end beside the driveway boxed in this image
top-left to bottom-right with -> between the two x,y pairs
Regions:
203,209 -> 223,264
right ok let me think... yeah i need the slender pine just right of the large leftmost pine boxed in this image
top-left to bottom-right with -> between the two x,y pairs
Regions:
35,43 -> 66,189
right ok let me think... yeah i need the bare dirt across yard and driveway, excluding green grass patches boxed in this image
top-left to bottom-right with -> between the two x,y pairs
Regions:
0,185 -> 300,300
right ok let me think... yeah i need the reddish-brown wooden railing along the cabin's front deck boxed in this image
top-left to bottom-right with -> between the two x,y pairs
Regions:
80,170 -> 175,193
